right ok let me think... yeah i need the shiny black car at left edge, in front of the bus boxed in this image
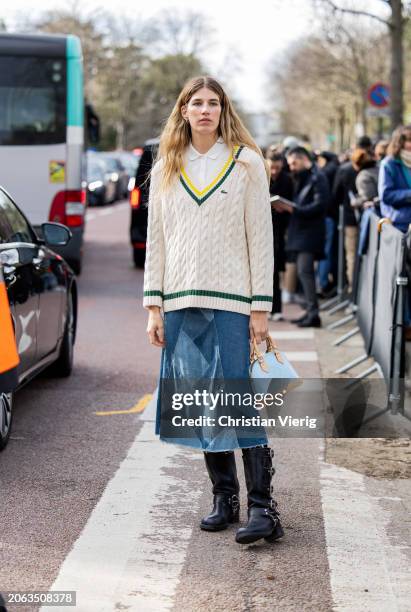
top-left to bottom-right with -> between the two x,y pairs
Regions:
0,187 -> 77,450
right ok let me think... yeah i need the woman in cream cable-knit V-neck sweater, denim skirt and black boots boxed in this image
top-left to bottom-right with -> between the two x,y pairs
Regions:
143,77 -> 283,543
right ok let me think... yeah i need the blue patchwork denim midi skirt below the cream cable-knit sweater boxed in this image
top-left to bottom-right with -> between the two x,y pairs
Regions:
155,308 -> 267,452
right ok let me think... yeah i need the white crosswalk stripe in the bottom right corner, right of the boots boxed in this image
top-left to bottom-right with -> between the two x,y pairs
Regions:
319,444 -> 411,612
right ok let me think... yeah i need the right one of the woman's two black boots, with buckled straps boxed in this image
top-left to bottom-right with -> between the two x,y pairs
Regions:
235,446 -> 284,544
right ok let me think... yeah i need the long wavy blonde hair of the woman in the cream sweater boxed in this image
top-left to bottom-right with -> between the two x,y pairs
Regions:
156,76 -> 269,191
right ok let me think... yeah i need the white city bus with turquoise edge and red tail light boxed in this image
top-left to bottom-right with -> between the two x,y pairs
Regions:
0,34 -> 91,274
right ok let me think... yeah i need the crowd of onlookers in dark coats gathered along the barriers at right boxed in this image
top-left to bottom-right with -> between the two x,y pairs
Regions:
264,125 -> 411,327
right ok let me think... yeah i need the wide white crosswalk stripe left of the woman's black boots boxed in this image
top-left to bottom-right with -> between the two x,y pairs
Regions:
40,420 -> 201,612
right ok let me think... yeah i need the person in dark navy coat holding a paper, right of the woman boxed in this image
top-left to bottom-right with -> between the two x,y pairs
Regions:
278,147 -> 329,327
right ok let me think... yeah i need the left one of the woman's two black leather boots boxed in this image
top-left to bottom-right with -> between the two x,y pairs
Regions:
200,451 -> 240,531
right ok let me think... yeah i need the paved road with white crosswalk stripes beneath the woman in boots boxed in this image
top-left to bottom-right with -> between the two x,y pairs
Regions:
0,203 -> 411,612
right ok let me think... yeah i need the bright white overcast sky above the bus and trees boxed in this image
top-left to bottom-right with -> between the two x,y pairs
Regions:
1,0 -> 312,112
